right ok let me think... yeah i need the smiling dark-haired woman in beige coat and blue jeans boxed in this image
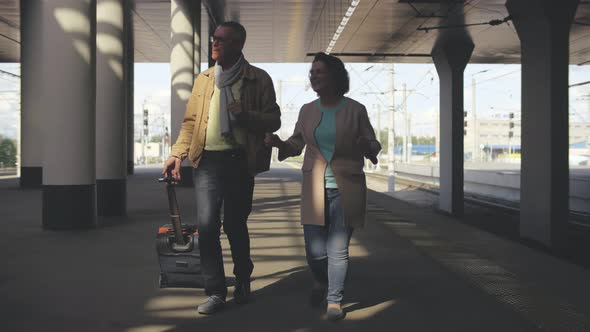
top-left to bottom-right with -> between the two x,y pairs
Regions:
265,53 -> 381,320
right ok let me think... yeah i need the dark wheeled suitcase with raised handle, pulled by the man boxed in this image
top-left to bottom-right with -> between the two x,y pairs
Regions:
156,178 -> 204,288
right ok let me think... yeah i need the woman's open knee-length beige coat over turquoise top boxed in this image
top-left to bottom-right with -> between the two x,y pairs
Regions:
279,98 -> 381,228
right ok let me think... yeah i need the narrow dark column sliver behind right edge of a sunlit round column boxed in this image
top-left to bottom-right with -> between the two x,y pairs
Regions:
123,0 -> 135,175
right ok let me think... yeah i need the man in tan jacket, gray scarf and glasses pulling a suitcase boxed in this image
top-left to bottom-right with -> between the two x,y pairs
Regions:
163,22 -> 281,314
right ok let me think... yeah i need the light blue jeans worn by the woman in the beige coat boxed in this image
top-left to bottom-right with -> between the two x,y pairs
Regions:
303,188 -> 353,303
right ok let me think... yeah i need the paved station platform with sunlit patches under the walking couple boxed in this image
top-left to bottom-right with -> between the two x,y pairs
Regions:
0,164 -> 590,332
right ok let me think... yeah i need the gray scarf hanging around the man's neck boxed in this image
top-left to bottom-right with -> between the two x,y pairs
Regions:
214,55 -> 248,138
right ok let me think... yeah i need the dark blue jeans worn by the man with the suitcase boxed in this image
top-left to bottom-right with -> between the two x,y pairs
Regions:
194,150 -> 254,297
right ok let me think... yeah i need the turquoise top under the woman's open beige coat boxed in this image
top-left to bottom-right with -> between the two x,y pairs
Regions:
314,97 -> 346,188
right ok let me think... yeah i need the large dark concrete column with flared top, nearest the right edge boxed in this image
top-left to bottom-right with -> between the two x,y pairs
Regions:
506,0 -> 579,247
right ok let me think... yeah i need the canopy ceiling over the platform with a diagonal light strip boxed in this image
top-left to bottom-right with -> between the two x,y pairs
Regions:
0,0 -> 590,64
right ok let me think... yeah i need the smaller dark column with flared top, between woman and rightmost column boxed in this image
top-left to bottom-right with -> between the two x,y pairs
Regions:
432,34 -> 474,216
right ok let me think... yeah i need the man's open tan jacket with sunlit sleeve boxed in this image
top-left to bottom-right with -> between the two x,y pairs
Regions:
170,64 -> 281,175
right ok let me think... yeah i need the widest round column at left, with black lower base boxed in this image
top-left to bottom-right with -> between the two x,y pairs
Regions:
37,0 -> 96,229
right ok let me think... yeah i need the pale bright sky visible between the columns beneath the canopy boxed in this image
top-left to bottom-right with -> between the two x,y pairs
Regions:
0,63 -> 590,139
